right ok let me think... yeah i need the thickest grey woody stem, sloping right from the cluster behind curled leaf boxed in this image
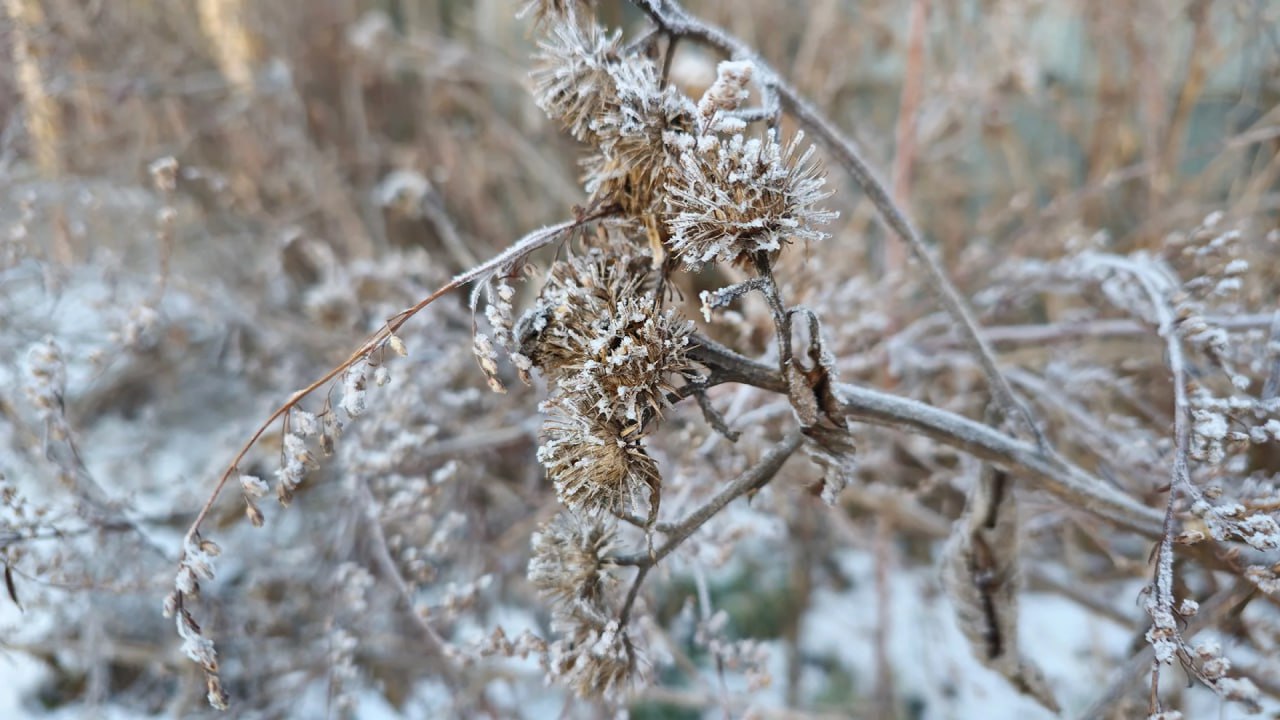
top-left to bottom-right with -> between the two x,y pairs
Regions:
690,337 -> 1164,538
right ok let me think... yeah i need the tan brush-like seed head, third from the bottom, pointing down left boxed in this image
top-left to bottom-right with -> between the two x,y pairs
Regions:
538,395 -> 662,518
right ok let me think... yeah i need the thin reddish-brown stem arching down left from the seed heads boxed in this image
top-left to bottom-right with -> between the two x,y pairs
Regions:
183,210 -> 612,555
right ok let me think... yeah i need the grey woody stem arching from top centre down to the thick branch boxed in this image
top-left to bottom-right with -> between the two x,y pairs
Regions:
632,0 -> 1050,451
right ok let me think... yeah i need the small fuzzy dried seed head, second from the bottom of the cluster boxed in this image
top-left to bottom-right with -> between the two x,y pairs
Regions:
529,512 -> 617,616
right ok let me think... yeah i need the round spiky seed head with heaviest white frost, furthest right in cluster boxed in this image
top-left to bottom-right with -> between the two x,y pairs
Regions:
666,132 -> 837,268
